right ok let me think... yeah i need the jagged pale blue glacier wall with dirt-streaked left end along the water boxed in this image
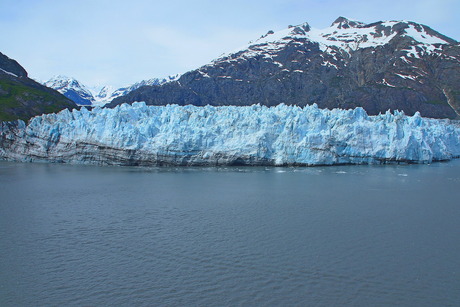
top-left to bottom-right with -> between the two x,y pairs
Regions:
0,102 -> 460,166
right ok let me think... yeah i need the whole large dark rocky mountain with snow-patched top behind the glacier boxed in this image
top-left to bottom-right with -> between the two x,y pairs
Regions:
108,17 -> 460,118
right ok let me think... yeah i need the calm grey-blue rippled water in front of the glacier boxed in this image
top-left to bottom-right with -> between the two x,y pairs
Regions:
0,161 -> 460,306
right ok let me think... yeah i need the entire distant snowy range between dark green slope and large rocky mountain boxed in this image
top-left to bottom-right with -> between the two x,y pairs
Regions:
44,75 -> 179,106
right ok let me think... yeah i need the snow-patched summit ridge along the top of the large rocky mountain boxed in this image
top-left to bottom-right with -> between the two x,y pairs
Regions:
214,17 -> 458,62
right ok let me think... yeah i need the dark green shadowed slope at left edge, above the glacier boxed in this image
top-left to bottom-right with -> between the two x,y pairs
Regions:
0,53 -> 76,121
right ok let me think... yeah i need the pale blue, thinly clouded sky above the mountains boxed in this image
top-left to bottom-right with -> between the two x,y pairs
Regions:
0,0 -> 460,87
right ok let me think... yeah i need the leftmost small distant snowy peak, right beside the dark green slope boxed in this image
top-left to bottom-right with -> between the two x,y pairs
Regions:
44,75 -> 95,106
